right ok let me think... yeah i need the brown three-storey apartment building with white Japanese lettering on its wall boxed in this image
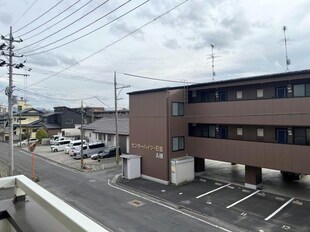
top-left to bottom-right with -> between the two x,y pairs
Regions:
129,70 -> 310,188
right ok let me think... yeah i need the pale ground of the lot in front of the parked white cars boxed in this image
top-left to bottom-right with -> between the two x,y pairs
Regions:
23,145 -> 116,171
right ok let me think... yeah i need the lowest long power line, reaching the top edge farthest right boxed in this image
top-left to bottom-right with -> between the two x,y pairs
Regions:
28,0 -> 189,87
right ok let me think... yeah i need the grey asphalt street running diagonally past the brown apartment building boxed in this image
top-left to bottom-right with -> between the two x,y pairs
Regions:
0,143 -> 235,231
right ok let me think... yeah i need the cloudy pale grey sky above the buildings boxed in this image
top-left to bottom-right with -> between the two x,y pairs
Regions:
0,0 -> 310,110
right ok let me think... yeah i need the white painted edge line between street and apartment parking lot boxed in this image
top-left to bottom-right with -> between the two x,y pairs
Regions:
108,180 -> 232,232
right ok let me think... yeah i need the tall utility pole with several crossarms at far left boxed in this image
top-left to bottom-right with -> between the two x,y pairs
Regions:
1,27 -> 22,176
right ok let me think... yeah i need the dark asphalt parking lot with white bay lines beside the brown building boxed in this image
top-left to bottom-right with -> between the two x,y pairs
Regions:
119,177 -> 310,232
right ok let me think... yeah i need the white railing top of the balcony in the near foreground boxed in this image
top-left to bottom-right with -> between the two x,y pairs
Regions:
0,175 -> 108,232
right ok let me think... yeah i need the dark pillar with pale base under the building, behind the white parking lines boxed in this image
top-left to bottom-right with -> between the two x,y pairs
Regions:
244,166 -> 262,189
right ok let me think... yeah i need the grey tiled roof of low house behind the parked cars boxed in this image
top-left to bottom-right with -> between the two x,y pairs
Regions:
84,115 -> 129,135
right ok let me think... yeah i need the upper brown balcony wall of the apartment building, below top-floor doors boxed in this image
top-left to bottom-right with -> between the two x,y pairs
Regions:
185,97 -> 310,126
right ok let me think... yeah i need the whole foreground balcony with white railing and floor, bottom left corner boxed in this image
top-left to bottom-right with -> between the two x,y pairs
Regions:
0,175 -> 107,232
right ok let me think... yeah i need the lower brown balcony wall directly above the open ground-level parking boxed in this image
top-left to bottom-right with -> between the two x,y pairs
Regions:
186,137 -> 310,174
